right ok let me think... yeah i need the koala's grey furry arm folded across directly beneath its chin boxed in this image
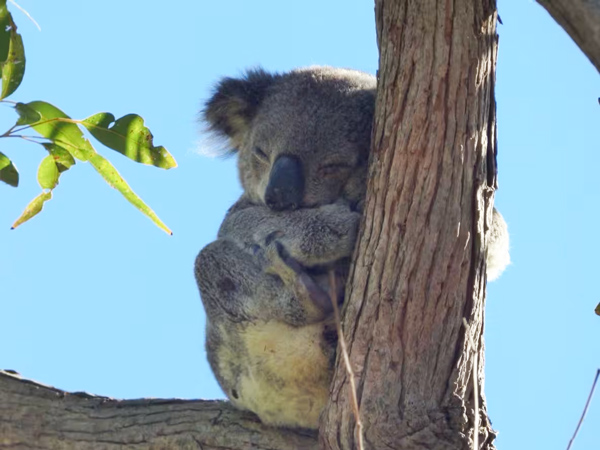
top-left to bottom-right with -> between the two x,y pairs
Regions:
219,197 -> 360,267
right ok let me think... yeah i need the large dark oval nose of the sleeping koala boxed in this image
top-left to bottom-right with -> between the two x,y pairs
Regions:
265,155 -> 304,211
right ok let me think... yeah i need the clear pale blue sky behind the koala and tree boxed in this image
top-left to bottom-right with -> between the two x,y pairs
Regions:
0,0 -> 600,450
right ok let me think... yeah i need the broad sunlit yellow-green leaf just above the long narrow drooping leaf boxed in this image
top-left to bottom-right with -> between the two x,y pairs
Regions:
15,101 -> 96,161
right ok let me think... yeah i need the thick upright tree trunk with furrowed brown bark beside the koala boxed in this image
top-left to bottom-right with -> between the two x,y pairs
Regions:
320,0 -> 497,450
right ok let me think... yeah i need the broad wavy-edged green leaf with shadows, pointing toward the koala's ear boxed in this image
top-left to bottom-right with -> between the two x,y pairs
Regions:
80,113 -> 177,169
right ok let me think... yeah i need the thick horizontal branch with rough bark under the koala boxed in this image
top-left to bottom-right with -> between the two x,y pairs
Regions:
0,371 -> 318,450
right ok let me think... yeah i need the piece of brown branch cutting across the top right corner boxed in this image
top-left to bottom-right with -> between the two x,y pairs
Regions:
537,0 -> 600,72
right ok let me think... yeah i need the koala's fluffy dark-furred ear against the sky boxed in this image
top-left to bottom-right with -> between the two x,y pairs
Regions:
202,69 -> 279,145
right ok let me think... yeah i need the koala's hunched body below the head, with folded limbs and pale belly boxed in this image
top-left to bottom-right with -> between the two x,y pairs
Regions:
196,198 -> 360,428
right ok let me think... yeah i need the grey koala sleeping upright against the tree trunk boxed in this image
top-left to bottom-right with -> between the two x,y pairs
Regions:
195,67 -> 509,429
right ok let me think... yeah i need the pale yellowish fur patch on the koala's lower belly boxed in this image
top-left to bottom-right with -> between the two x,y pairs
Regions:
219,321 -> 330,428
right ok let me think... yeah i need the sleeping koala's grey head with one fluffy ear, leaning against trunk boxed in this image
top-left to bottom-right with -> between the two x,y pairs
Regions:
204,67 -> 376,210
